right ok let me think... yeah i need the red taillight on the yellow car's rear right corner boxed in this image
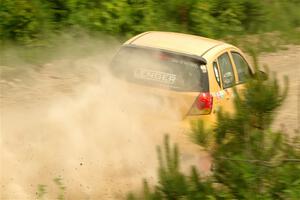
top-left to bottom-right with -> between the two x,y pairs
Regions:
189,92 -> 213,115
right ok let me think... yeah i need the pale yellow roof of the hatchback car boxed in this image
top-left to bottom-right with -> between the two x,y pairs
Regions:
125,31 -> 226,56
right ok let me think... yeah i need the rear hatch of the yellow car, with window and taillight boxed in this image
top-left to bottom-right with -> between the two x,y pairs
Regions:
111,45 -> 212,118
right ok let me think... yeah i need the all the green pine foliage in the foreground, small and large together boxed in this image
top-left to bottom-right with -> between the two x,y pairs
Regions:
128,54 -> 300,200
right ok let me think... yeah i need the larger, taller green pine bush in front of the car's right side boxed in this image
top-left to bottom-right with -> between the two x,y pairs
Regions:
195,56 -> 300,199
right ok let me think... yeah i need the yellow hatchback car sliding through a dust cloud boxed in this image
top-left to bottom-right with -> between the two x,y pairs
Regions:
111,32 -> 254,128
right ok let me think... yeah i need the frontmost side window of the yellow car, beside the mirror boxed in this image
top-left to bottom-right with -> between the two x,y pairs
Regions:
231,52 -> 250,83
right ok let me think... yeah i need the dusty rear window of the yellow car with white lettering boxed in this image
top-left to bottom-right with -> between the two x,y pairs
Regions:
111,47 -> 208,91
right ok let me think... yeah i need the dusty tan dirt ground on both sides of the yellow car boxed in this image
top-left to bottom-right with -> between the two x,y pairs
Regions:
0,46 -> 300,199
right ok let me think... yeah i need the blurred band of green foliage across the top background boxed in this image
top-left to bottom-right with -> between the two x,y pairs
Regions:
0,0 -> 300,45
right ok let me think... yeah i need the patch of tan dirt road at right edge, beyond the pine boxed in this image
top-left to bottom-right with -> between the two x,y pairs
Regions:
259,46 -> 300,134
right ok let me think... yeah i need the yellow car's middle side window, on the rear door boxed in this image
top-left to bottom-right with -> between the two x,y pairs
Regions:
218,52 -> 235,89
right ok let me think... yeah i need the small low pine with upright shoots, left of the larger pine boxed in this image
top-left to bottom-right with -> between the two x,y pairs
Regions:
127,136 -> 221,200
